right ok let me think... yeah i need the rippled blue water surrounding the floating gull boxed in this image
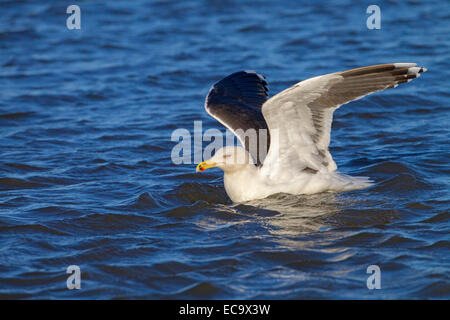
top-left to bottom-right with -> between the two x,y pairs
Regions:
0,0 -> 450,299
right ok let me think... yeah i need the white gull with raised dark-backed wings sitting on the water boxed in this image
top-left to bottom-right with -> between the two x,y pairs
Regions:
197,63 -> 427,202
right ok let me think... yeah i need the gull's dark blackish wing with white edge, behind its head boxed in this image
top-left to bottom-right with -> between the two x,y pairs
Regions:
205,71 -> 270,165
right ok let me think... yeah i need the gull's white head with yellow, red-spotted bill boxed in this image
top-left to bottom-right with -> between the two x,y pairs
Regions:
196,146 -> 254,172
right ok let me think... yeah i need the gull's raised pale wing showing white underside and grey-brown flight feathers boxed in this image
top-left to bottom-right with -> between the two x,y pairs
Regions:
262,63 -> 426,176
